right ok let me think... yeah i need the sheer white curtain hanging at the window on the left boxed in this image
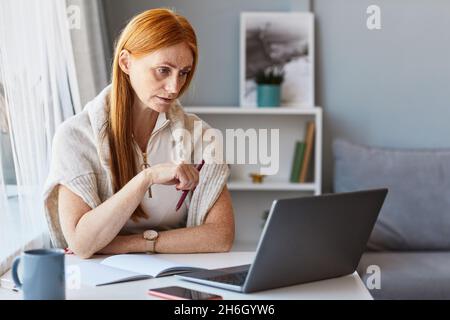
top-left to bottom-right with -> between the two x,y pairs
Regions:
0,0 -> 81,274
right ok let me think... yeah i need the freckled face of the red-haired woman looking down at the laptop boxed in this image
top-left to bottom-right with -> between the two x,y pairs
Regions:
119,43 -> 194,112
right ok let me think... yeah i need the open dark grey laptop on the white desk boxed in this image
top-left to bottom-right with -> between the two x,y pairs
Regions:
177,189 -> 388,293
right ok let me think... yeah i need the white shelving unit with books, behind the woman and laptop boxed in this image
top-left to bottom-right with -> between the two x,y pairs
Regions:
184,106 -> 322,246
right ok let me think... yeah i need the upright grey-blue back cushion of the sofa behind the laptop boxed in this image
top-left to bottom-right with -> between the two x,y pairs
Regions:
333,140 -> 450,250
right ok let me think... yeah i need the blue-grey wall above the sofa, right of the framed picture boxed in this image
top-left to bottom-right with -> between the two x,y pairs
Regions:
312,0 -> 450,190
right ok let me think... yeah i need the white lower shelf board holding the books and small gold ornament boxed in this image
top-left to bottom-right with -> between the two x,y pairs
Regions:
227,181 -> 316,191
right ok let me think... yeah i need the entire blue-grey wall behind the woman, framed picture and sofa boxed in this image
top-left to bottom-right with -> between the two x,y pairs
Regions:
104,0 -> 450,191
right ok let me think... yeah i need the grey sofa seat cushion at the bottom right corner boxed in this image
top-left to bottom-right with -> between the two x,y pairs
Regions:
358,251 -> 450,299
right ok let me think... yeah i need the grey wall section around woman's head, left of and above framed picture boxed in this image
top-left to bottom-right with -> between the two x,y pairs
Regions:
103,0 -> 309,106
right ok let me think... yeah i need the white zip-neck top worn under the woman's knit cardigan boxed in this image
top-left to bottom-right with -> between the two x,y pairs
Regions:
121,112 -> 188,234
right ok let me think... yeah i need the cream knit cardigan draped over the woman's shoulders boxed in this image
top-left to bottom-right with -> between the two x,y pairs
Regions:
43,86 -> 230,248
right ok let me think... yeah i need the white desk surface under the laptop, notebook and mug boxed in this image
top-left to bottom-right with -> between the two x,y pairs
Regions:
0,252 -> 372,300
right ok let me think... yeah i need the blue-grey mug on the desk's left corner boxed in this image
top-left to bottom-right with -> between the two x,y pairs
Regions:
12,249 -> 66,300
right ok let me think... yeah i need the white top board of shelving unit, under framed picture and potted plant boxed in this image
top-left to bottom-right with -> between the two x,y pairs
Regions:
184,107 -> 322,115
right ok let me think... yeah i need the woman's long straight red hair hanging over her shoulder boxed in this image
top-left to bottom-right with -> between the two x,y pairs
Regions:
105,9 -> 198,221
